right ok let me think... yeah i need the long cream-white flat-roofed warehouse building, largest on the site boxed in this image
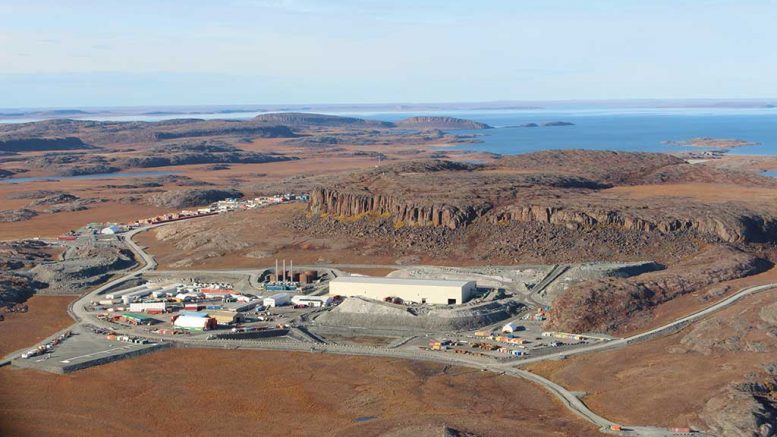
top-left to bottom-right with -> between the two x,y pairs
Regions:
329,276 -> 477,305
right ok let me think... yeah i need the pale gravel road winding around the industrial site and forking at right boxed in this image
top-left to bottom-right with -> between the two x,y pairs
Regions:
0,220 -> 777,437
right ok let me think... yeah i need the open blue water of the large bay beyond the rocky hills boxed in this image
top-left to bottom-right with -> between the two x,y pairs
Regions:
350,109 -> 777,155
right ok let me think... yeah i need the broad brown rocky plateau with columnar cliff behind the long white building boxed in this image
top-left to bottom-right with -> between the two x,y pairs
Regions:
309,150 -> 777,243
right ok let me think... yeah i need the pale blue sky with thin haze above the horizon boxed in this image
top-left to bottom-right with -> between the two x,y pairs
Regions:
0,0 -> 777,108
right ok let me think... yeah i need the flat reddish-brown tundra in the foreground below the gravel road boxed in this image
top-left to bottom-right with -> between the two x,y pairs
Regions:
0,349 -> 597,436
